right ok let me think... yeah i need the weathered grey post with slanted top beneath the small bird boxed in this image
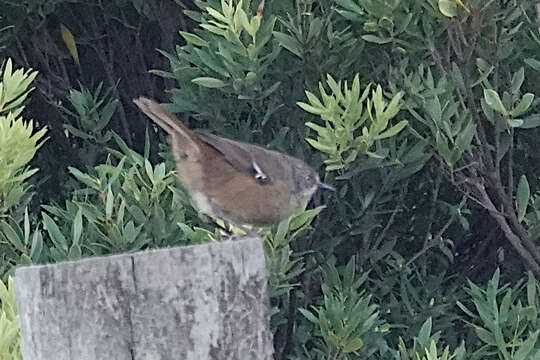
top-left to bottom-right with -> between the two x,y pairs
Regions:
15,238 -> 273,360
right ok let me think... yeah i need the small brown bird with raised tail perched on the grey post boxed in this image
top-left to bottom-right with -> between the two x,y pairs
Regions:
133,97 -> 333,226
